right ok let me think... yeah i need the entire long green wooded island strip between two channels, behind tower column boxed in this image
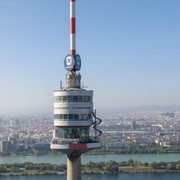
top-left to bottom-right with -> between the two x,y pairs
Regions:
0,159 -> 180,175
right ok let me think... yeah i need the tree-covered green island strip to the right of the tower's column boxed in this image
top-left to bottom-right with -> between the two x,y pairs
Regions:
83,159 -> 180,173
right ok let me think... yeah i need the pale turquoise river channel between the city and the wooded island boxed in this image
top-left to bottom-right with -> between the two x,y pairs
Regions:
0,153 -> 180,164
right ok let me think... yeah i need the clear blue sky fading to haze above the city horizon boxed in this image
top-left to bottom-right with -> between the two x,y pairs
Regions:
0,0 -> 180,113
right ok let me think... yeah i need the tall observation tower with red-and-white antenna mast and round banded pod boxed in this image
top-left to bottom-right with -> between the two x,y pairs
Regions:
51,0 -> 102,180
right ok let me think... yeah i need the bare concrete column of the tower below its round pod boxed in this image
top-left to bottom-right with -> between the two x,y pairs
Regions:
67,156 -> 81,180
